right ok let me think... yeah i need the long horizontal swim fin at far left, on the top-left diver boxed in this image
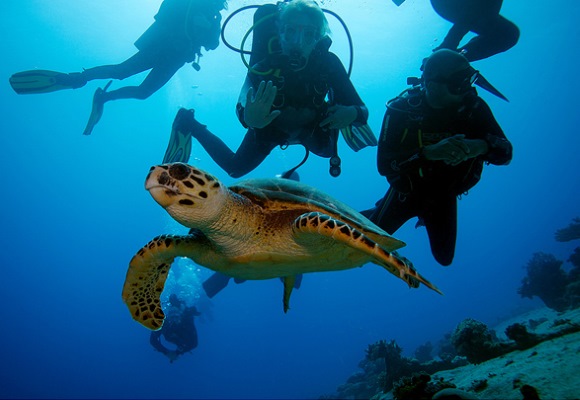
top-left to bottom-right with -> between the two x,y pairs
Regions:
9,69 -> 87,94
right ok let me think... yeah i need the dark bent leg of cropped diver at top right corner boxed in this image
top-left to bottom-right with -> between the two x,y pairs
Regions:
461,15 -> 520,61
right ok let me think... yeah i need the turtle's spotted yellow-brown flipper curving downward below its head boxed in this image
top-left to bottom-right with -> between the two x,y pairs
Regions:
123,234 -> 212,330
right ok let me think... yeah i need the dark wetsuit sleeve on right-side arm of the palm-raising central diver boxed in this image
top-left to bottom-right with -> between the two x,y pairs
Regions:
326,53 -> 369,126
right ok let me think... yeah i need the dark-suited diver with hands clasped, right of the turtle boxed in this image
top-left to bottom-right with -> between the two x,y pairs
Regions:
361,49 -> 512,266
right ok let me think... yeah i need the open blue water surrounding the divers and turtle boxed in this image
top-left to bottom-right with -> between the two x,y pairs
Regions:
0,0 -> 580,398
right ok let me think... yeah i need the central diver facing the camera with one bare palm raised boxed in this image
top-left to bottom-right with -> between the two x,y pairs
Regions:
163,0 -> 377,178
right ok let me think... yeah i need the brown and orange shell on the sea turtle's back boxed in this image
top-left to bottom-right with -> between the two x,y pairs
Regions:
229,178 -> 405,251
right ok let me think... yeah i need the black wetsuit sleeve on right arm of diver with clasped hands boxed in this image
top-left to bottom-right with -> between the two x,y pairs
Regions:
472,99 -> 513,165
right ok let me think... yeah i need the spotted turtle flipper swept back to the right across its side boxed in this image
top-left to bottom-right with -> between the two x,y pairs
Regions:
293,212 -> 443,294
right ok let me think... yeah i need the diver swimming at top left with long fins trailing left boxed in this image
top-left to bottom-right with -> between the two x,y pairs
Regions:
10,0 -> 227,135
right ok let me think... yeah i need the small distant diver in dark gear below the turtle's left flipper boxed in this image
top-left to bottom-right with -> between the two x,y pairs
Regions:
149,293 -> 201,363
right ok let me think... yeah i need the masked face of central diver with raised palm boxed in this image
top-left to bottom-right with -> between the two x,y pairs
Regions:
280,14 -> 320,69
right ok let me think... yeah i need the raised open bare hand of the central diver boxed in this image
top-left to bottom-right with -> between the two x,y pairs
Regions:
244,81 -> 280,128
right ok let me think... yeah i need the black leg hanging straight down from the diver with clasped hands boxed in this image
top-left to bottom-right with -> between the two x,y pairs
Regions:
420,195 -> 457,266
